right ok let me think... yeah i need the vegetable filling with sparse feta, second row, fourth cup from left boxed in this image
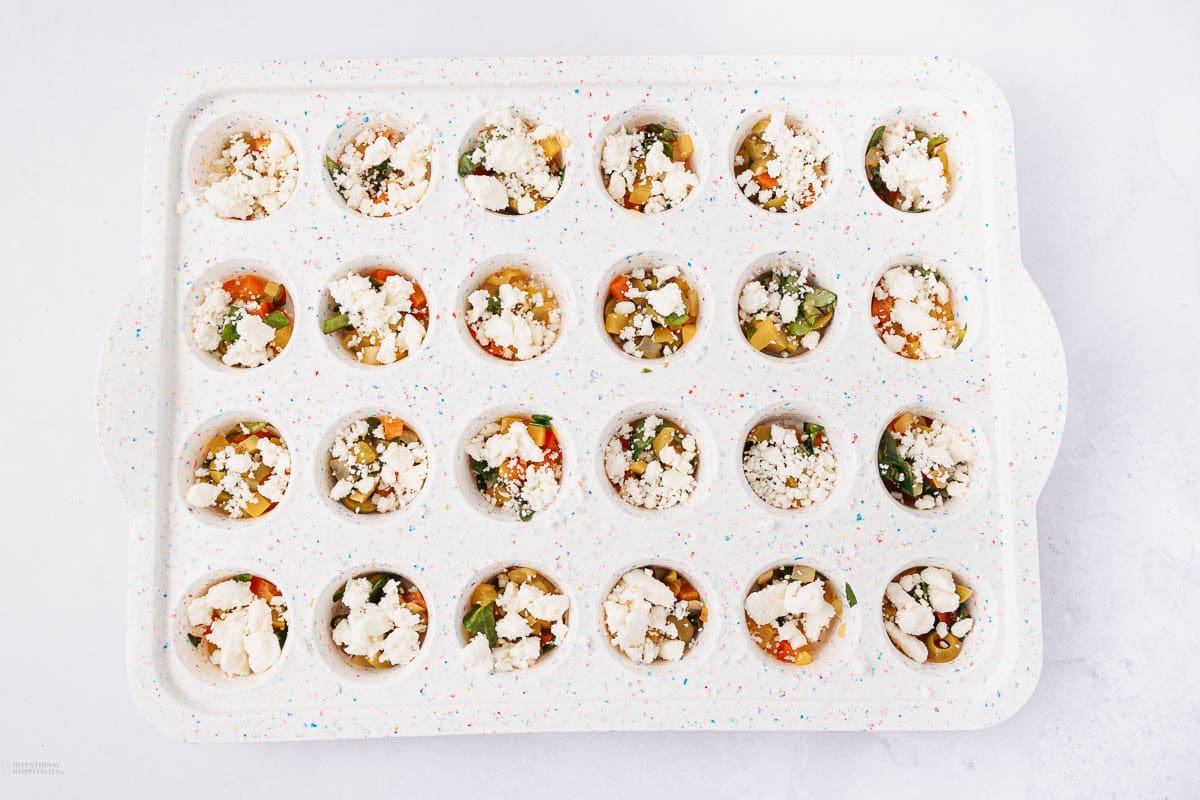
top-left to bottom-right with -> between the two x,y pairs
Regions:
604,264 -> 700,359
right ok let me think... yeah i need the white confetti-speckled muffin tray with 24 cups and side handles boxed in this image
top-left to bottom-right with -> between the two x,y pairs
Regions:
97,56 -> 1067,741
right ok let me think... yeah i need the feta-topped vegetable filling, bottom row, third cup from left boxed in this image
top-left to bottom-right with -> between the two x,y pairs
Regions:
462,566 -> 570,672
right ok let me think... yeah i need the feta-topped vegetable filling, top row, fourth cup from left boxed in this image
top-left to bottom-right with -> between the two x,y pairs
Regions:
600,122 -> 700,213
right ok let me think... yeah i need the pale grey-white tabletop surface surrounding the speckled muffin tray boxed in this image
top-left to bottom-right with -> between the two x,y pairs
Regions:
0,0 -> 1200,799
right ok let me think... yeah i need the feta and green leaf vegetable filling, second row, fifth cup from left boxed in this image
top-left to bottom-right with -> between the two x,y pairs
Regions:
738,266 -> 838,359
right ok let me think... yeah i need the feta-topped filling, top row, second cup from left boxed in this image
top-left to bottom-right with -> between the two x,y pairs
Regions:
326,126 -> 431,217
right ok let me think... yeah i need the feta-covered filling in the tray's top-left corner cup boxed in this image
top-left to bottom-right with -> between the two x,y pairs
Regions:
203,131 -> 300,219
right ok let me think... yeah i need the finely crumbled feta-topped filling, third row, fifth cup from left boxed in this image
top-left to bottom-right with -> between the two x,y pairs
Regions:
742,423 -> 838,509
